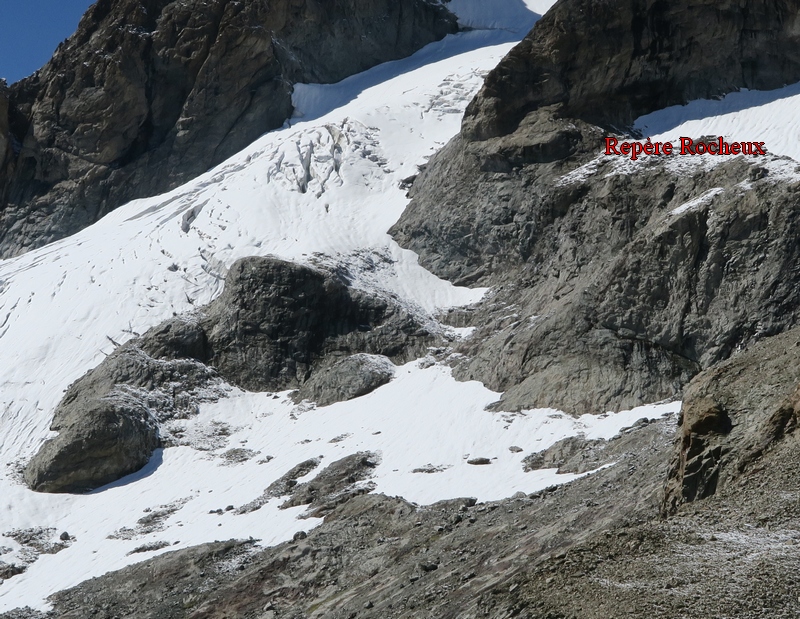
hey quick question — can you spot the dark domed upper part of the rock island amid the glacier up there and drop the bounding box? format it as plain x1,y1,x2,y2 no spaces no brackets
200,258,433,391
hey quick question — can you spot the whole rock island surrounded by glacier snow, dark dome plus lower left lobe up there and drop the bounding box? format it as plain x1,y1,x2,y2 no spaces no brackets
24,258,434,492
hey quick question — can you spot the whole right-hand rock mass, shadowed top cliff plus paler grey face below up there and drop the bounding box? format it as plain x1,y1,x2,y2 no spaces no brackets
391,0,800,413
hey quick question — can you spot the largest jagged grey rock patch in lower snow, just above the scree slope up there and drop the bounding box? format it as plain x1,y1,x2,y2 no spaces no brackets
281,451,380,518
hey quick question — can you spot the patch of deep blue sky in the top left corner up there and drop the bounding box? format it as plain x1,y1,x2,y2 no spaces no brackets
0,0,94,84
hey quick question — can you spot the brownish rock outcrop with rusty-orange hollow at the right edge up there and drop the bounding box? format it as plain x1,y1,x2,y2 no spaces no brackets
663,328,800,513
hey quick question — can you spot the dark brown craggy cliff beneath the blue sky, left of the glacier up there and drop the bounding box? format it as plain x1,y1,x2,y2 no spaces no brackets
0,0,457,257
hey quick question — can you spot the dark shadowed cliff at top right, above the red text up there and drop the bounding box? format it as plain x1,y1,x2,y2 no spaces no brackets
463,0,800,140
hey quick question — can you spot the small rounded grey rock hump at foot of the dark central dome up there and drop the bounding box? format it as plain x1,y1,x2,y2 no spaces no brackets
293,353,395,406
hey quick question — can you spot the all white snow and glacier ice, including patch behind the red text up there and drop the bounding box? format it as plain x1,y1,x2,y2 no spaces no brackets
0,0,800,612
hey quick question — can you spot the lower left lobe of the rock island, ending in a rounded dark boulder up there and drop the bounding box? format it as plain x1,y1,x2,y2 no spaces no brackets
24,345,220,492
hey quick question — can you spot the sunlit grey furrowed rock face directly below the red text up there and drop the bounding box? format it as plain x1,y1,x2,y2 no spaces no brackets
400,149,800,413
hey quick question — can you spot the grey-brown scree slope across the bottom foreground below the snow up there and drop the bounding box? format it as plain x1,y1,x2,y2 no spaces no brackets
10,418,752,619
